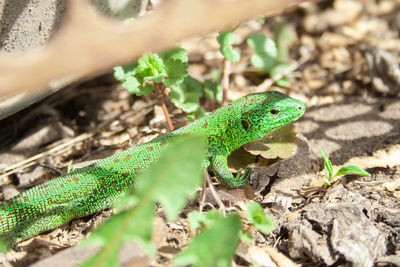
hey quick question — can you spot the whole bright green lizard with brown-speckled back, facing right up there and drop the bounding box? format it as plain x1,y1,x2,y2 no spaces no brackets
0,92,305,246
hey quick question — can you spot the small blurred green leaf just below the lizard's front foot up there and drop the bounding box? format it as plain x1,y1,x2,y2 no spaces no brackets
247,201,275,234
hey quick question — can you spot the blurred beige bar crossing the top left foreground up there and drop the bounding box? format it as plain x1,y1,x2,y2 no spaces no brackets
0,0,310,113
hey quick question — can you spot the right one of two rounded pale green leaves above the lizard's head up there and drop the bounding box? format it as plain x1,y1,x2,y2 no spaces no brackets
247,34,278,72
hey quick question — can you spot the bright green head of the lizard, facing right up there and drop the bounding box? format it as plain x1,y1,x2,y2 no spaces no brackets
240,91,306,141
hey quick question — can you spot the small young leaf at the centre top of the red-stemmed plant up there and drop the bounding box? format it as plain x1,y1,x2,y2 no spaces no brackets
137,54,167,83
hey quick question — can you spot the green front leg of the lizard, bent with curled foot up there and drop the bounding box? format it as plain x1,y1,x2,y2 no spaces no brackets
211,155,253,188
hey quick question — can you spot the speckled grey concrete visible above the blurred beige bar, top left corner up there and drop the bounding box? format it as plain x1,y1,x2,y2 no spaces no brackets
0,0,145,52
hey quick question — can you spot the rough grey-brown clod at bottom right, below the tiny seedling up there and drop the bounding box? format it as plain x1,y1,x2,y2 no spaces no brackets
289,185,386,266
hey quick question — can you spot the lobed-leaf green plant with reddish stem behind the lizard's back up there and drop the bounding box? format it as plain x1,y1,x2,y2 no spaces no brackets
114,48,203,131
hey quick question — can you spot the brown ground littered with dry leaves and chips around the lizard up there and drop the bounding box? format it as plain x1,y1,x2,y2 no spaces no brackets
0,0,400,266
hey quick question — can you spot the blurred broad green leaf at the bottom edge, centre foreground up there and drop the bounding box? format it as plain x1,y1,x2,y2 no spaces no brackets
173,214,241,267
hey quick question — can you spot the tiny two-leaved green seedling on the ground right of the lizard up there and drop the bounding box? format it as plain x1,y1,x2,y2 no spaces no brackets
319,148,371,187
